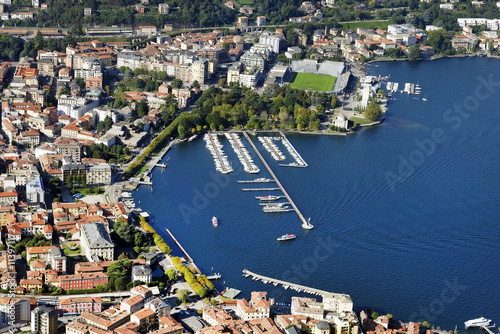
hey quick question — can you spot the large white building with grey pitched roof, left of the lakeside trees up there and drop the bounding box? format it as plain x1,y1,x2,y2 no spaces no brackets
80,223,115,262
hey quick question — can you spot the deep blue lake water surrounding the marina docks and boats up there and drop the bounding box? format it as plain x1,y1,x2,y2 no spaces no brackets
134,58,500,330
